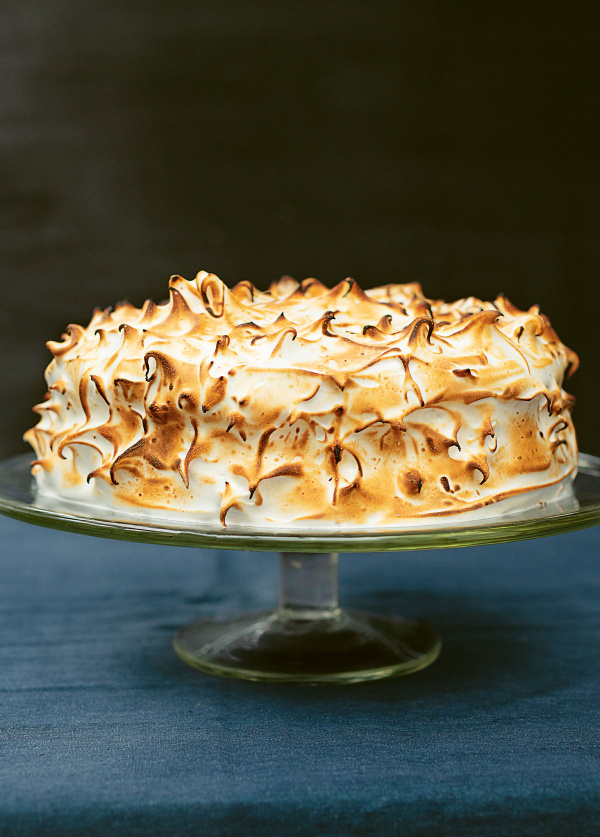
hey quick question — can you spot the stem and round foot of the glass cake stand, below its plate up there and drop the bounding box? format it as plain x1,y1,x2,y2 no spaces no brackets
173,552,441,684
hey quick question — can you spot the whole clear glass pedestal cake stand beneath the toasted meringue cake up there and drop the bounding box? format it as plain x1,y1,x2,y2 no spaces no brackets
0,454,600,683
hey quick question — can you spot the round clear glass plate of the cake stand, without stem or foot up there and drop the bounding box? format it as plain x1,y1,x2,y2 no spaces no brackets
0,453,600,552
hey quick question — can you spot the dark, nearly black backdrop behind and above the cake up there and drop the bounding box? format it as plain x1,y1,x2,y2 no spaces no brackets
0,0,600,456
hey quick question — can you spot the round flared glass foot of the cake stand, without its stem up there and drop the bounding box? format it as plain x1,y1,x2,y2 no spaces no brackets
173,611,440,684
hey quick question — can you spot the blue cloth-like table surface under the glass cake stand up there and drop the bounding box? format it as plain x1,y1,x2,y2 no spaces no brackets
0,519,600,837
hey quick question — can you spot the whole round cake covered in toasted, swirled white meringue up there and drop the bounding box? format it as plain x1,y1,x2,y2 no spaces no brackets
25,272,577,528
